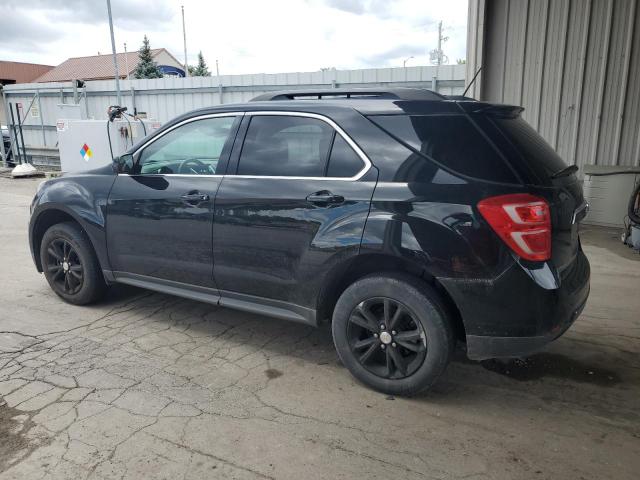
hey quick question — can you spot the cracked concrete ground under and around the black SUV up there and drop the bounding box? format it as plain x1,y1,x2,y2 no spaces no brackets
0,178,640,480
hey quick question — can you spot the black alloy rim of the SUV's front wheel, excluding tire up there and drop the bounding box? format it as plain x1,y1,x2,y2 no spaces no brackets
46,238,84,295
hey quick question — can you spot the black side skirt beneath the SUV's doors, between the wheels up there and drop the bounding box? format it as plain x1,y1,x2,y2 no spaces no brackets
103,270,318,327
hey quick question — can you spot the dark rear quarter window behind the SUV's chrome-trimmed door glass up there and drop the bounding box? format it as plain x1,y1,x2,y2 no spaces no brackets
370,115,517,183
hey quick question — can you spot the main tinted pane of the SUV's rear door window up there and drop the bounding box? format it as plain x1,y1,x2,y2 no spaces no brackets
238,115,333,177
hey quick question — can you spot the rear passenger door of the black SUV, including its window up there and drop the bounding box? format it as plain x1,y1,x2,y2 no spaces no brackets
213,112,377,316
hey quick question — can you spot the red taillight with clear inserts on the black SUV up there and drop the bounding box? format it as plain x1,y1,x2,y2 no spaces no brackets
478,193,551,261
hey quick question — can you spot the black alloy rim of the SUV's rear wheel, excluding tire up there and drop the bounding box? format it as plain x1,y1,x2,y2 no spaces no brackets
347,297,427,379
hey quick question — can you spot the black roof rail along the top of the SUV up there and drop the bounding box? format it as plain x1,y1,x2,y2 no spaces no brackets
251,87,446,102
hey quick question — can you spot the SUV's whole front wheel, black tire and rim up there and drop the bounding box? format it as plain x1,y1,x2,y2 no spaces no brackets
40,222,107,305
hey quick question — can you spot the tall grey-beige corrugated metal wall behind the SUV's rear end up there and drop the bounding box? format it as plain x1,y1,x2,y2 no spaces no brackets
467,0,640,171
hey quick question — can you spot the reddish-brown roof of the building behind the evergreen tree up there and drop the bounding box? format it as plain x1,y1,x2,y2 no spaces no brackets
35,48,180,82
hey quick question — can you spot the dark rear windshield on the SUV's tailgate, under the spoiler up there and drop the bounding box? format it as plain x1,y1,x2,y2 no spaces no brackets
474,115,567,179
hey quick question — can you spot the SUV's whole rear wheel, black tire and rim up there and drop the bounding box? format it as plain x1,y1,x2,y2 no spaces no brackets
332,274,455,395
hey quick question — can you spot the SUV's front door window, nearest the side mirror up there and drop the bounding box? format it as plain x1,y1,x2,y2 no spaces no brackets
138,117,235,175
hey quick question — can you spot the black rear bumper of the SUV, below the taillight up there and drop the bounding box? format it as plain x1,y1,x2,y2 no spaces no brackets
441,249,590,360
